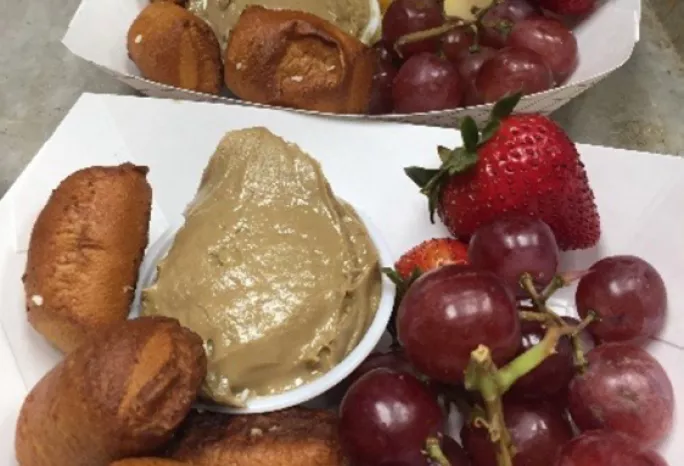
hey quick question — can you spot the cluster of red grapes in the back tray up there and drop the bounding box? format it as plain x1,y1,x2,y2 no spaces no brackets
370,0,578,114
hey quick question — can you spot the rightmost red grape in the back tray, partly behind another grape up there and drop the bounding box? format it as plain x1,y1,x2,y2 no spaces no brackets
506,17,579,84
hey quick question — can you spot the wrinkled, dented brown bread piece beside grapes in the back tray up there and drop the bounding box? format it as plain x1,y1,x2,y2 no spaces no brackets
224,6,375,113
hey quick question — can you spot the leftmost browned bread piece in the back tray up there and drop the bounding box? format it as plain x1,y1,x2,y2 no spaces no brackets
127,1,223,94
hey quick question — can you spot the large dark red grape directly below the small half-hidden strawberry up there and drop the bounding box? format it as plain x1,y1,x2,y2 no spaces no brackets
397,265,521,383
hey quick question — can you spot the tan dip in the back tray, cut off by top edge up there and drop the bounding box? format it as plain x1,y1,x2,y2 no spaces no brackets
188,0,371,46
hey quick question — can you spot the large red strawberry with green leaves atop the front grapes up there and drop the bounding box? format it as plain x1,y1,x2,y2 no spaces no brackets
406,94,600,250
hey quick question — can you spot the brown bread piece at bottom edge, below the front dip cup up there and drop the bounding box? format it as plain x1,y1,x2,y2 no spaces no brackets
169,408,348,466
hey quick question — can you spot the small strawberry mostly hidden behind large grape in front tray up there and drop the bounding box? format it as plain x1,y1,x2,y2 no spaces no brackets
394,238,468,280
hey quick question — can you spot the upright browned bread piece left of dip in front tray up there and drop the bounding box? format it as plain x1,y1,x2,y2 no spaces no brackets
23,163,152,352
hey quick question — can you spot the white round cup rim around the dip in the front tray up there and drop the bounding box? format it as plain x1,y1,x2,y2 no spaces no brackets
130,208,396,414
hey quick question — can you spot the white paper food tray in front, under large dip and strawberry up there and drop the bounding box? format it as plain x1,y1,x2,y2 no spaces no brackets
0,94,684,466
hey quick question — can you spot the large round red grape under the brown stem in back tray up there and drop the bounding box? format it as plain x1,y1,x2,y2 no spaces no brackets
392,53,463,113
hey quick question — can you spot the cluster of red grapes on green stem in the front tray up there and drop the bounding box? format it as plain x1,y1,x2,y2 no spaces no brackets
340,215,674,466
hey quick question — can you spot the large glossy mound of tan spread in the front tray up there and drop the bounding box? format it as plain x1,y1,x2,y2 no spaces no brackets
143,128,381,406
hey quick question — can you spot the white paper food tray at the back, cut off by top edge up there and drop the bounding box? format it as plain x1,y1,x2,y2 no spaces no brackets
62,0,641,128
